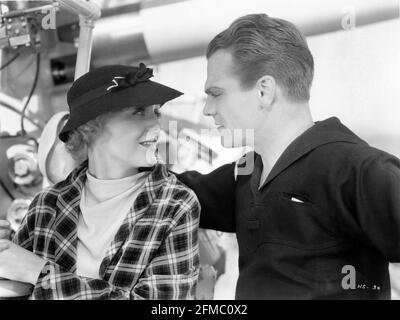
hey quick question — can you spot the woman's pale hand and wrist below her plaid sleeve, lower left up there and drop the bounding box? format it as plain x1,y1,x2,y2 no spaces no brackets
0,240,46,285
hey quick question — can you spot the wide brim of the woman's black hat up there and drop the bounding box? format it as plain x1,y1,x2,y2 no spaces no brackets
59,81,183,142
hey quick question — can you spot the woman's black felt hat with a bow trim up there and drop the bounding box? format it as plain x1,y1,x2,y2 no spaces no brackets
59,63,183,142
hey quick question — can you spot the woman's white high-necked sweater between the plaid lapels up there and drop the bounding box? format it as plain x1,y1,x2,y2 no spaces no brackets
76,171,149,279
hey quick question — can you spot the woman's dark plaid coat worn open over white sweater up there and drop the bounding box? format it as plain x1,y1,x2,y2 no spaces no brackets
13,163,200,299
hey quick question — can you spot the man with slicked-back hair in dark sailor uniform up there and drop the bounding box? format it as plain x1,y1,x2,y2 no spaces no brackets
180,14,400,299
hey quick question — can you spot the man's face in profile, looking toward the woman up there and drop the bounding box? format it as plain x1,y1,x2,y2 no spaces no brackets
203,50,260,148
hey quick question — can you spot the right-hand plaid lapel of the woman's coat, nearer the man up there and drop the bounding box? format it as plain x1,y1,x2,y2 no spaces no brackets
100,164,168,283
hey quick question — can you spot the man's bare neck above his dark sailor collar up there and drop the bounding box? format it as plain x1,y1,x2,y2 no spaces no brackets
255,109,314,187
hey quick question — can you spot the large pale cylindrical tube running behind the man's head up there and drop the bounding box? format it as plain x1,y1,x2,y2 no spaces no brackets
93,0,399,63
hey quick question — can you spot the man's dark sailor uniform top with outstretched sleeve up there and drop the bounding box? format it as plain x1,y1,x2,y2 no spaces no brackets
179,118,400,299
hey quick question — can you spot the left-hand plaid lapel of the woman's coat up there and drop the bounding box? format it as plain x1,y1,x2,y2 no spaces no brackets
54,163,87,272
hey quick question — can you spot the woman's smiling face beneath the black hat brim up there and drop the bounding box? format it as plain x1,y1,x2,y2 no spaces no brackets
91,105,160,168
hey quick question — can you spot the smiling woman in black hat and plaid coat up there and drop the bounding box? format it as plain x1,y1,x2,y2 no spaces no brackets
0,64,200,299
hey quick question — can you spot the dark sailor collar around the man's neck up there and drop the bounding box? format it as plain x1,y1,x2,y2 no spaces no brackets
252,117,366,190
